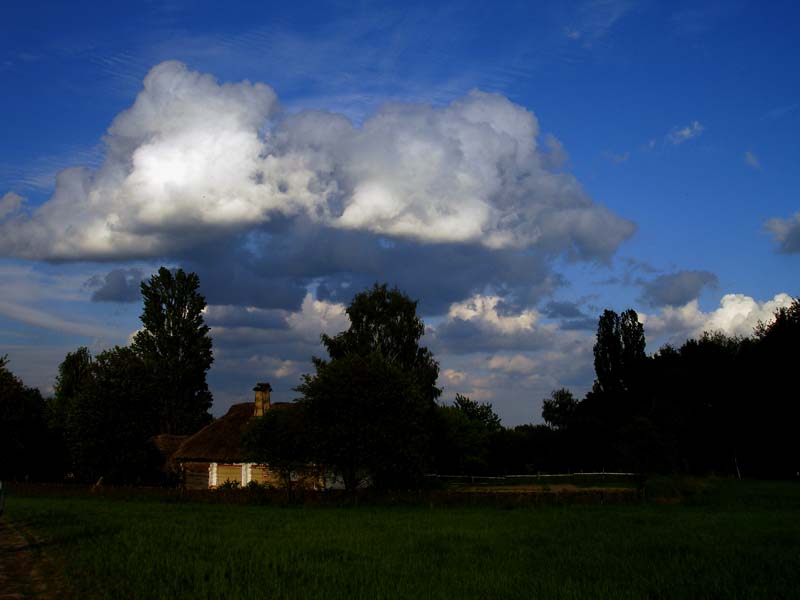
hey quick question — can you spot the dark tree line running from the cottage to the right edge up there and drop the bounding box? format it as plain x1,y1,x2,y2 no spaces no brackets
245,285,800,489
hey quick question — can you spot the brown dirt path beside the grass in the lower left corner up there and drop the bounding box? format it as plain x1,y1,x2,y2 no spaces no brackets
0,516,68,600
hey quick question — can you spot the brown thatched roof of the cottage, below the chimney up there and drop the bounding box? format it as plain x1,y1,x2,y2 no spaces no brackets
172,402,254,463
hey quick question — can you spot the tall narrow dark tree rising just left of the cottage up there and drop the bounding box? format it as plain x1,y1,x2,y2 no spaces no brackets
131,267,214,434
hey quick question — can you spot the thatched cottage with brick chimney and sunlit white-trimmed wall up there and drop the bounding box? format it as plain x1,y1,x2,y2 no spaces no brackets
172,383,280,489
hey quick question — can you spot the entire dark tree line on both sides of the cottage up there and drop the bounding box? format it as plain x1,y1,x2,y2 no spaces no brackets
0,269,800,489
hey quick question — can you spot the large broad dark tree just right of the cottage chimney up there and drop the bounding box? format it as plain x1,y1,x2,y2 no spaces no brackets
297,284,440,489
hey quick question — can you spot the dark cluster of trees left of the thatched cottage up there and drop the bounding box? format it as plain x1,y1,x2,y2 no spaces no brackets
0,267,213,484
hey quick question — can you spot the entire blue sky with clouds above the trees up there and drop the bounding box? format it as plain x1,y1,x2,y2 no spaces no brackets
0,0,800,425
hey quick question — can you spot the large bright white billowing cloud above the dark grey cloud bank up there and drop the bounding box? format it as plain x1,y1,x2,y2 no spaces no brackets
0,61,634,260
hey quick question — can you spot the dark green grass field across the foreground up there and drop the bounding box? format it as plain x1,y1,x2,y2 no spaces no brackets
4,481,800,599
